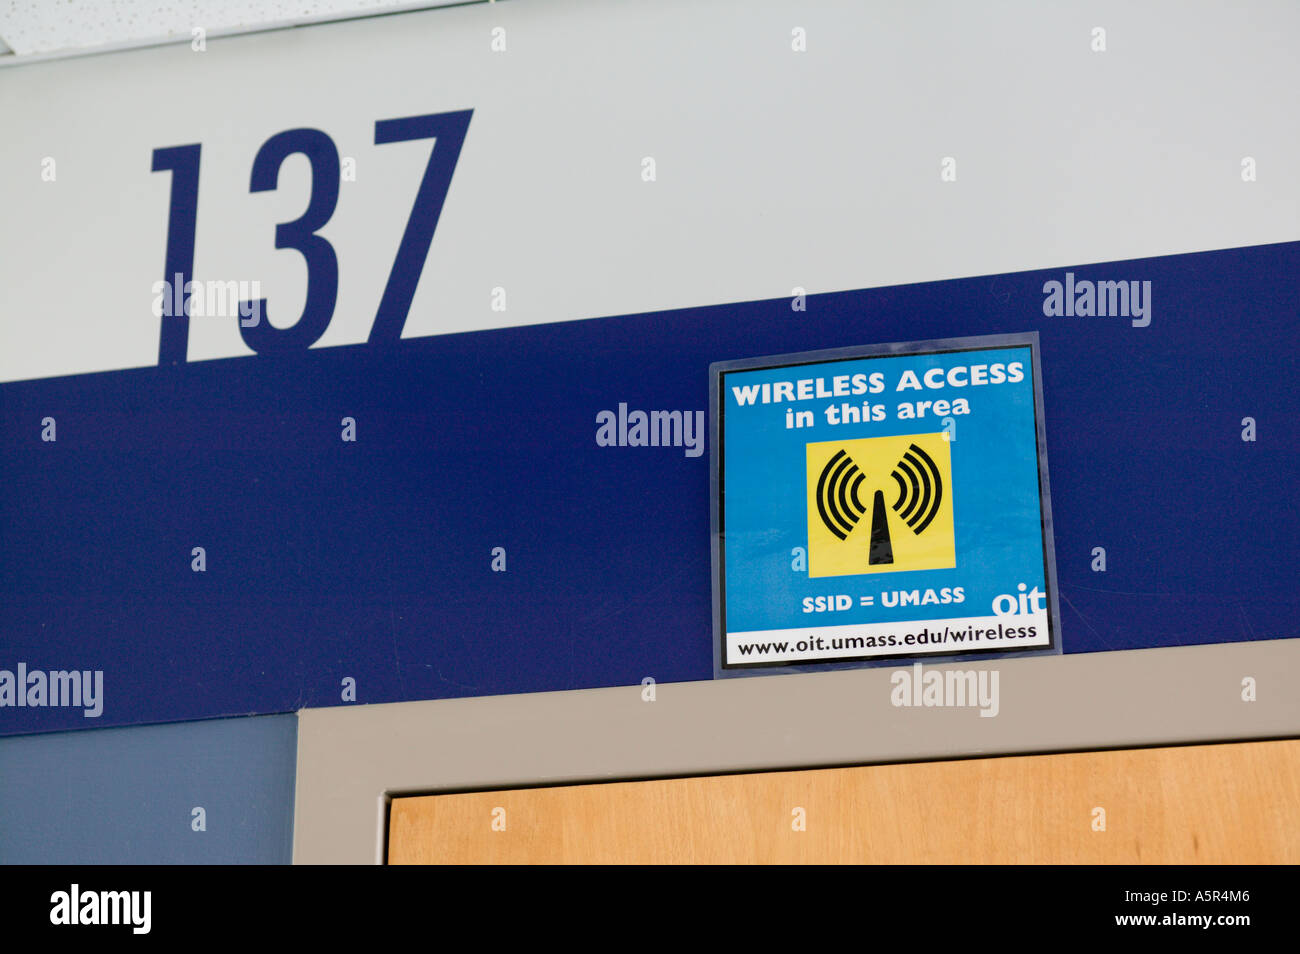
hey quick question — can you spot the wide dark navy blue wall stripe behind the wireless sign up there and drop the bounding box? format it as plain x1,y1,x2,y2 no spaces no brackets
0,242,1300,734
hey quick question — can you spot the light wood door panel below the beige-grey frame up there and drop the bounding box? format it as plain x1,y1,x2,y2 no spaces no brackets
389,741,1300,864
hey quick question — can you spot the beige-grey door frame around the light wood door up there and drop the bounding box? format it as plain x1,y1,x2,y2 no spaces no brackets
294,639,1300,864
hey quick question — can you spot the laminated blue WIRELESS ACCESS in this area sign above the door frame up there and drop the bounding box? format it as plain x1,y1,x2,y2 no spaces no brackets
711,334,1060,675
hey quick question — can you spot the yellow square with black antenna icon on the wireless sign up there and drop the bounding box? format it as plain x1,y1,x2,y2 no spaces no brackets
806,433,957,577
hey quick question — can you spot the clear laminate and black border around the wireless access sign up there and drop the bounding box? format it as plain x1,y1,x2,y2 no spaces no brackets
709,331,1061,678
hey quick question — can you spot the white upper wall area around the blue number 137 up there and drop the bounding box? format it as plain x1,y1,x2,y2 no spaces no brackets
0,0,1300,381
